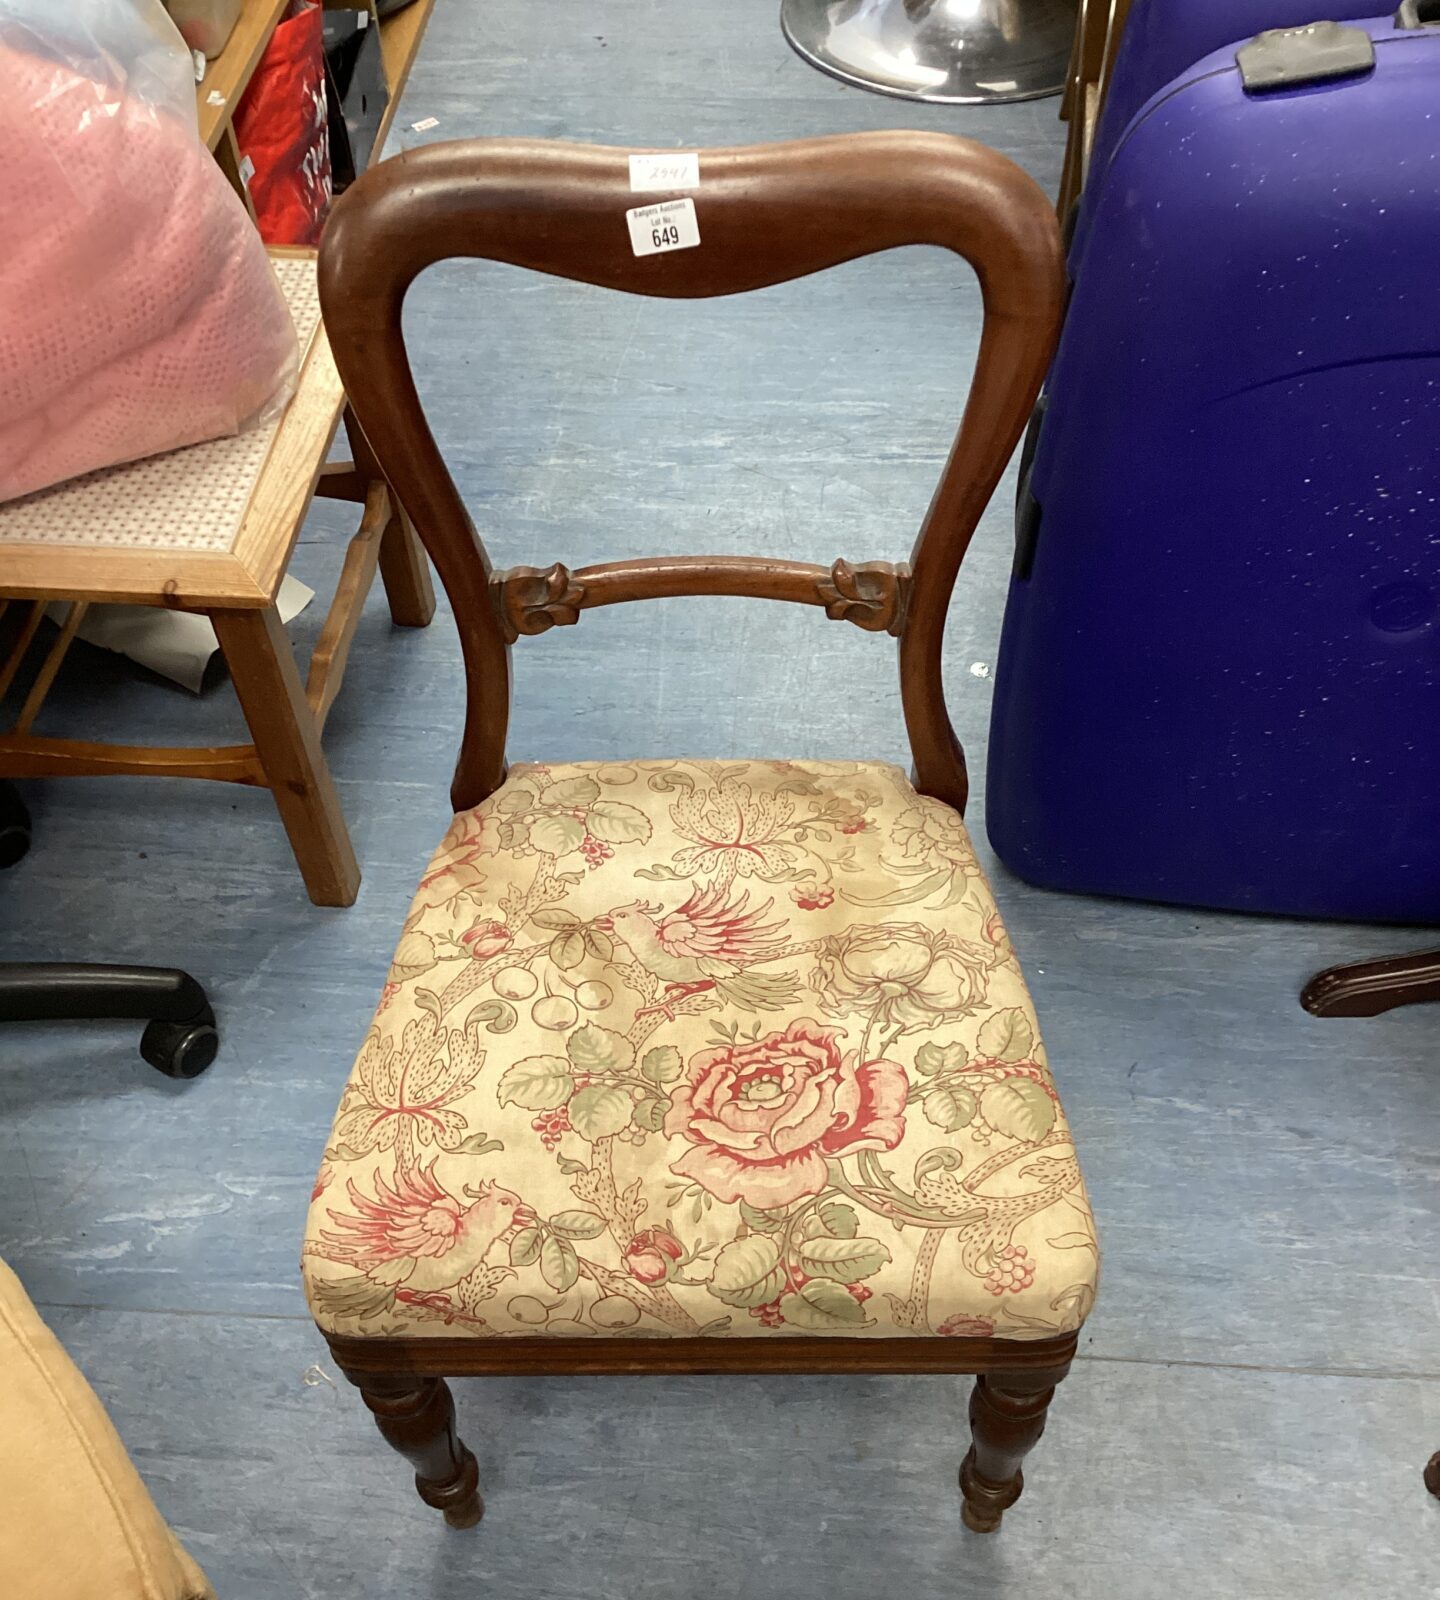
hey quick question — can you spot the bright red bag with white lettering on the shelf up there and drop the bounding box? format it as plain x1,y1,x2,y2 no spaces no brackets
235,0,330,245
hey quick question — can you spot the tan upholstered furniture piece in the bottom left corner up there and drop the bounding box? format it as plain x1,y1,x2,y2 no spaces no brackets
0,1262,214,1600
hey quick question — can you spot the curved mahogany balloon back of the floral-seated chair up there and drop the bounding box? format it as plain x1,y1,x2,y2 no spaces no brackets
320,133,1062,810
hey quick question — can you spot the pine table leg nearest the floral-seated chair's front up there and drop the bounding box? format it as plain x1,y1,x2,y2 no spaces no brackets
211,606,360,906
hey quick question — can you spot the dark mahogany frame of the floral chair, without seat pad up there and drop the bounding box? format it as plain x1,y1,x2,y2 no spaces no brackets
320,133,1077,1531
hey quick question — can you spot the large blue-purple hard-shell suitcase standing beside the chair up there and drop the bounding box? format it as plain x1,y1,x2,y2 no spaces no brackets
987,12,1440,922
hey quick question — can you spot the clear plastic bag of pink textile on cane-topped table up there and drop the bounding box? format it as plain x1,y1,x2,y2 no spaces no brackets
0,0,298,499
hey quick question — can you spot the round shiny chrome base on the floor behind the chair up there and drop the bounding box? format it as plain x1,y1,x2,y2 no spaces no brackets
781,0,1077,104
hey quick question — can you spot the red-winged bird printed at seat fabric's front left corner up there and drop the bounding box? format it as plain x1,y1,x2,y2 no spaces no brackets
304,1157,536,1317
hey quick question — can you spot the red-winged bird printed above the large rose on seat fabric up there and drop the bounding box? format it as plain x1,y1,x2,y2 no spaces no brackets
595,883,798,1022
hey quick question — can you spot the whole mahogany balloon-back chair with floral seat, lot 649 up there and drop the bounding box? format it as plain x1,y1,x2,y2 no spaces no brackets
304,133,1098,1531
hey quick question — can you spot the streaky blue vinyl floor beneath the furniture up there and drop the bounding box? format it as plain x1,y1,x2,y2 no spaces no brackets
0,0,1440,1600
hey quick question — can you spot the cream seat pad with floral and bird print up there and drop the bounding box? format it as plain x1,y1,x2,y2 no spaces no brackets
304,762,1098,1339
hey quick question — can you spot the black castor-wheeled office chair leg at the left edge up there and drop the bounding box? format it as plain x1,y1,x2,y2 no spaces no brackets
0,962,219,1078
